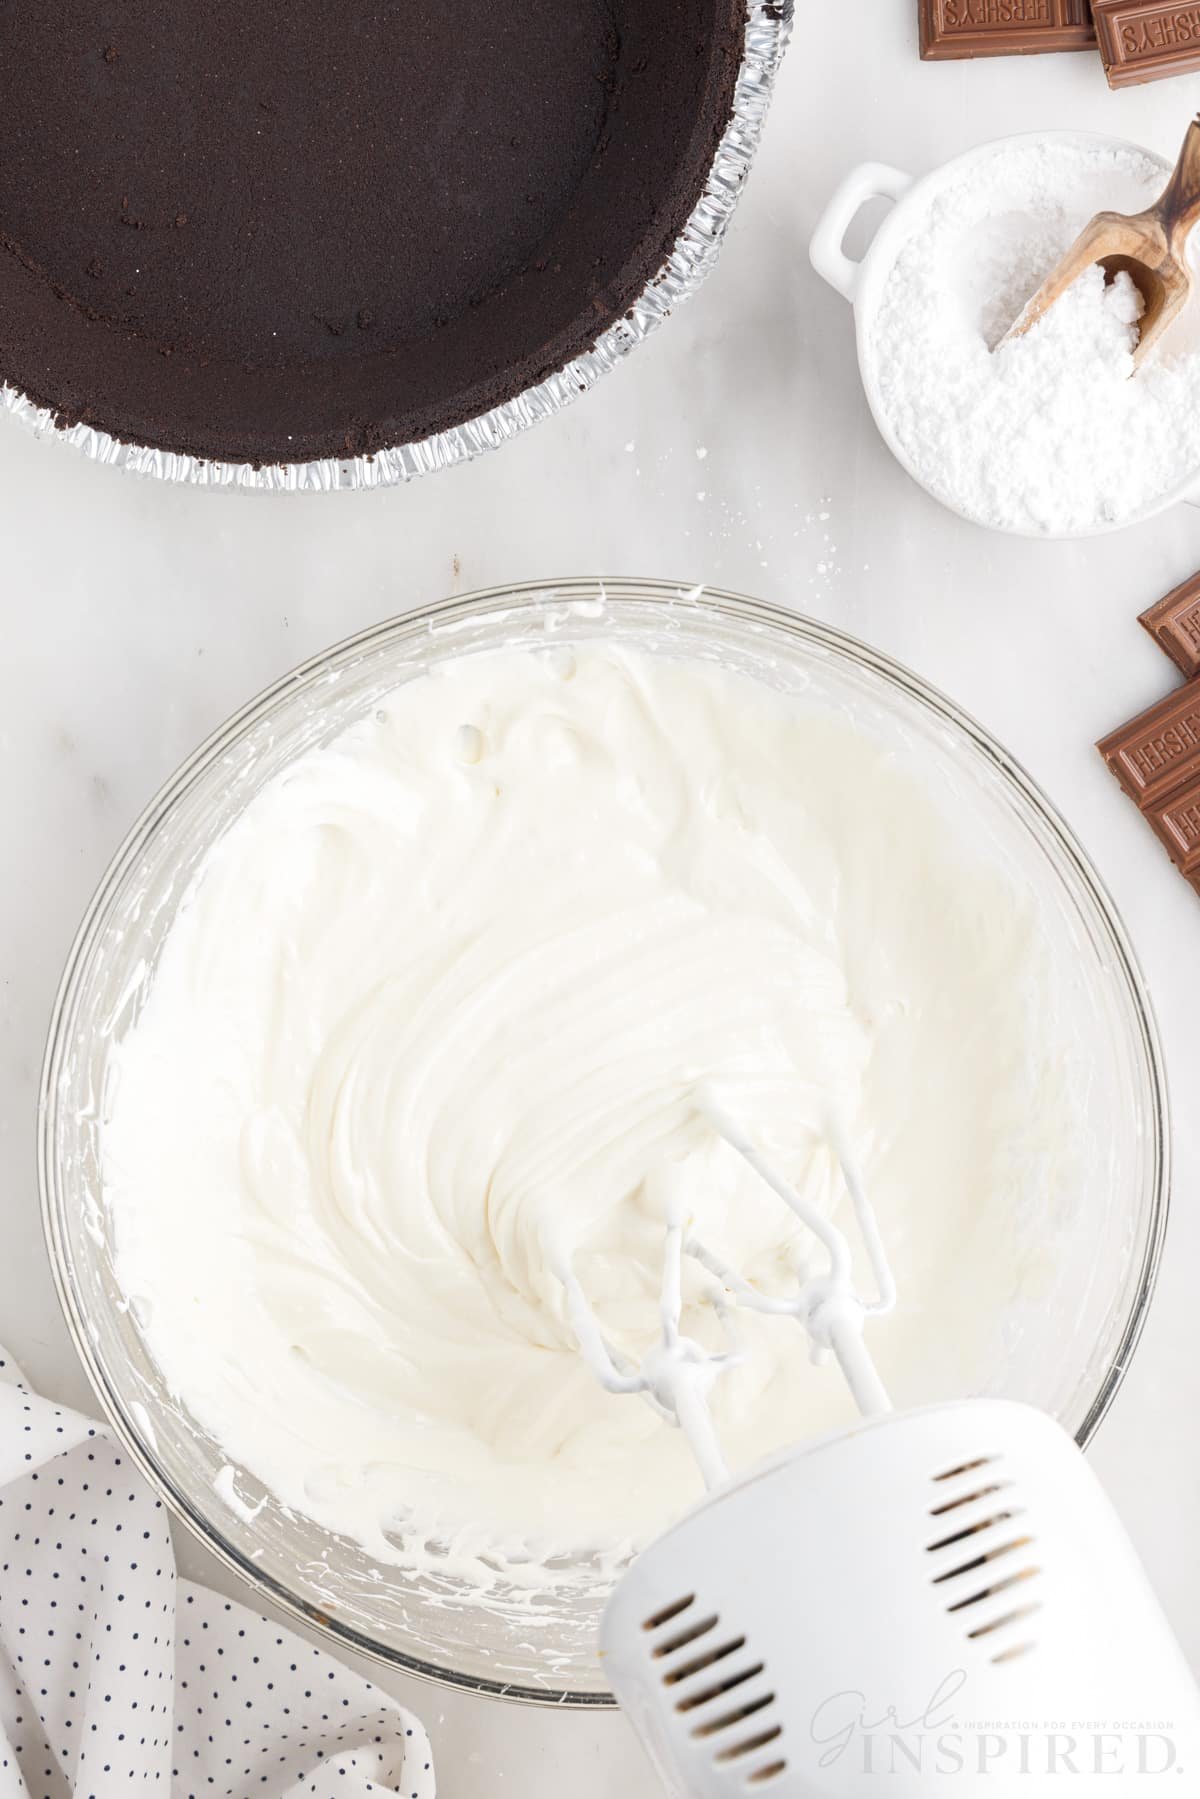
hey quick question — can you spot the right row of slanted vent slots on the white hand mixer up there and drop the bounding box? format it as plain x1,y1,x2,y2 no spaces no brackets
925,1455,1042,1664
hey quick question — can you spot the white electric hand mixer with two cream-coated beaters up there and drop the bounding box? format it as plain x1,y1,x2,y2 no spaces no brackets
560,1092,1200,1799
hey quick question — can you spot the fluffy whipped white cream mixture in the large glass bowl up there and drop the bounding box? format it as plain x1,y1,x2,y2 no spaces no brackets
103,640,1069,1581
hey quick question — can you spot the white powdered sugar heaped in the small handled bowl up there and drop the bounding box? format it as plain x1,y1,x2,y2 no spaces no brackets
864,139,1200,533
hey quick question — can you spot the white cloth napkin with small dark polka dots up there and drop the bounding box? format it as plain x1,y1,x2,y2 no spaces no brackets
0,1349,434,1799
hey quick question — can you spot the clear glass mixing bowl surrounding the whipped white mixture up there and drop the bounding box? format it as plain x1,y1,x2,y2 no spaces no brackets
40,581,1168,1705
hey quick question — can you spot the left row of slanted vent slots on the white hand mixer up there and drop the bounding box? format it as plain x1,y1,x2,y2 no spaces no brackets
642,1592,786,1790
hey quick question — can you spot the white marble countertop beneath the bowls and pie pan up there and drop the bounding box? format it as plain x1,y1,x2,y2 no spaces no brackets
0,0,1200,1799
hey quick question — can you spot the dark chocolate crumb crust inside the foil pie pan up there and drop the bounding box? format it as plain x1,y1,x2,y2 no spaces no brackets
0,0,745,464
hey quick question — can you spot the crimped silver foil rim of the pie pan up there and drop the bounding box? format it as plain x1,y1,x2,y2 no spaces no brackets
0,0,793,493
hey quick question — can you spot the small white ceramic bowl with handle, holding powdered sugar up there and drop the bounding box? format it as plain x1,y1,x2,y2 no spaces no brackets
808,131,1200,538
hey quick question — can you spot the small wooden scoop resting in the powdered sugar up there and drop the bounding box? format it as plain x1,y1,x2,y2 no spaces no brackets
1002,113,1200,367
